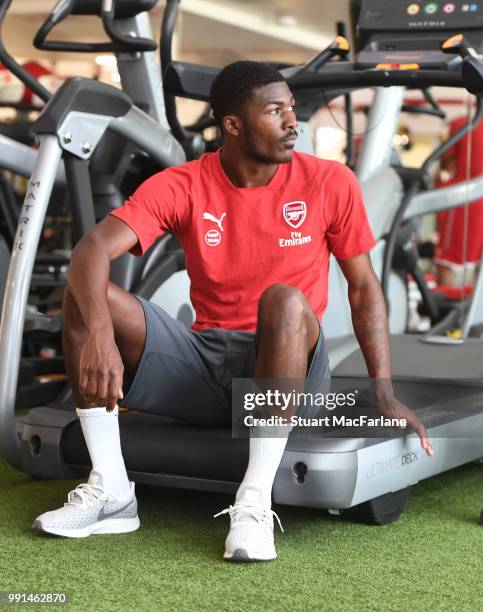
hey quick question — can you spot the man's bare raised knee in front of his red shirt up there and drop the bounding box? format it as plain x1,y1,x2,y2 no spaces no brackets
258,284,308,333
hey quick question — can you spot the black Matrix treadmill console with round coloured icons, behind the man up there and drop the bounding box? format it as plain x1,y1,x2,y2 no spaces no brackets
356,0,483,70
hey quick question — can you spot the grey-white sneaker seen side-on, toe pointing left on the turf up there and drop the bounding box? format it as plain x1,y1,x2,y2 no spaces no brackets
32,482,139,538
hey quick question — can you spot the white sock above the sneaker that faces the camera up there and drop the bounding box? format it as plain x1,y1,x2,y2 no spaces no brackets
236,427,292,508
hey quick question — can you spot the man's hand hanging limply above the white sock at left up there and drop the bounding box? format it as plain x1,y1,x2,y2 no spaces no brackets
79,330,124,411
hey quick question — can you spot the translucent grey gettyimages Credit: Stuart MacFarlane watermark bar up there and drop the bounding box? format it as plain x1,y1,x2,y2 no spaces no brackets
232,376,483,440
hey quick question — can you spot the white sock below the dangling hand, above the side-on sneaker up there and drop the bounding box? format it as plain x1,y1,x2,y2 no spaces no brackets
76,406,131,499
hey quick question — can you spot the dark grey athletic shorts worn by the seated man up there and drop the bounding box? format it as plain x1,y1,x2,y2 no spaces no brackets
120,296,330,425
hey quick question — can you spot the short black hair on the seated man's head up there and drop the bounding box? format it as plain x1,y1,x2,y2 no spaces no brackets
210,61,286,126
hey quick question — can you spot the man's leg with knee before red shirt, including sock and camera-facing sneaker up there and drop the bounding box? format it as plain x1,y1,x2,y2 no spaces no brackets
225,285,320,560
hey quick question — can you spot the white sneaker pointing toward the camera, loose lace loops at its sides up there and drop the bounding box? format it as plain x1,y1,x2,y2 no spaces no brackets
215,490,283,561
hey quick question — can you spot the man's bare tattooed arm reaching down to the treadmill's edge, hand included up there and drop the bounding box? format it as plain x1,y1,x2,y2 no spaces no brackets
338,254,433,455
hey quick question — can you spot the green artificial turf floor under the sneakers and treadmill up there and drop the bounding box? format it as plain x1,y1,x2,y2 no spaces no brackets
0,460,483,612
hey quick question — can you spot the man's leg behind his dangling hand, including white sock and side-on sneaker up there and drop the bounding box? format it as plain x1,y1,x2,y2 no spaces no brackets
34,283,146,537
